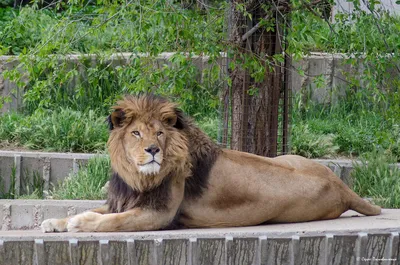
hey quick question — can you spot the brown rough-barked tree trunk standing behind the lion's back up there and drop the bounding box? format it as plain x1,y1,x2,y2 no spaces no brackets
229,0,284,156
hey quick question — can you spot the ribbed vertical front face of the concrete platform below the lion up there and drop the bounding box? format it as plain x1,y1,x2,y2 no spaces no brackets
0,233,399,265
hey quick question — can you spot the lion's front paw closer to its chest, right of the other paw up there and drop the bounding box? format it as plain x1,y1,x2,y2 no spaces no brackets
67,212,102,232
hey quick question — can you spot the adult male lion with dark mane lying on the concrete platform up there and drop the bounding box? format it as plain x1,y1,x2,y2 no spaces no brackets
42,95,381,232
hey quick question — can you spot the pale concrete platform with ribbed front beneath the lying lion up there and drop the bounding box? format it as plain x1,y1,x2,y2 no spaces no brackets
0,209,400,265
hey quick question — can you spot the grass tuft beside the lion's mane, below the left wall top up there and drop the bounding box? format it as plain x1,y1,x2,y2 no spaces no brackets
51,156,111,200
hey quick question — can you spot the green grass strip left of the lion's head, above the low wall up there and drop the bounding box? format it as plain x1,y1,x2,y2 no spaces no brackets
0,109,108,152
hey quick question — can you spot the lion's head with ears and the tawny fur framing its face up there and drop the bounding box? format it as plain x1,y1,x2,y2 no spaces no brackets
108,95,190,191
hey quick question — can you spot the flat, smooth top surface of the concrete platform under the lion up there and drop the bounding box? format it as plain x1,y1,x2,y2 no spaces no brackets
0,209,400,240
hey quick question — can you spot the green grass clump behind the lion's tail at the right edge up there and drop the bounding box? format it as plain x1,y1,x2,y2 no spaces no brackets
351,150,400,208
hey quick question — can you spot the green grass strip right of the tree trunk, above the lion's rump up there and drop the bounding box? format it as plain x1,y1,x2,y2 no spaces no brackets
292,95,400,161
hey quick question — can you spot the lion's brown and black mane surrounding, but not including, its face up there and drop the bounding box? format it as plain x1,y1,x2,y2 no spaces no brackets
107,94,220,212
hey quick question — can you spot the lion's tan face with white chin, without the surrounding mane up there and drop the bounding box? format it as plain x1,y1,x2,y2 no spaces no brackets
123,119,168,175
